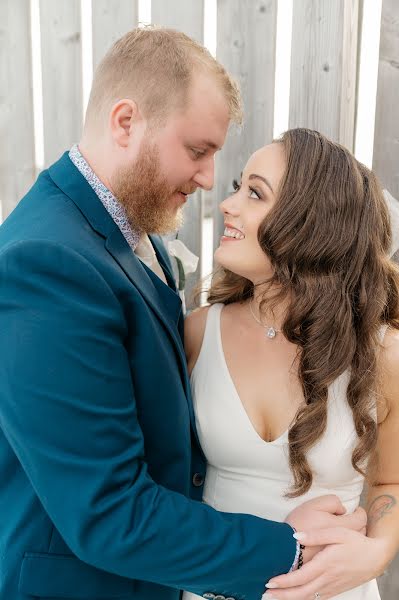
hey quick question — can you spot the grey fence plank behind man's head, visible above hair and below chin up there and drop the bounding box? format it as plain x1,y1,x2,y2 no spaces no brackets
151,0,204,308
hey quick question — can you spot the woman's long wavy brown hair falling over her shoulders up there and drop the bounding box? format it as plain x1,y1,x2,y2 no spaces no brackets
208,128,399,497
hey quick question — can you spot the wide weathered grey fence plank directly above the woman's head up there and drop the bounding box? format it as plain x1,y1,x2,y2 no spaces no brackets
289,0,359,150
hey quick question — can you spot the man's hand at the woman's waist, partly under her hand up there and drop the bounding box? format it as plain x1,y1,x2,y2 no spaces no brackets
285,494,367,564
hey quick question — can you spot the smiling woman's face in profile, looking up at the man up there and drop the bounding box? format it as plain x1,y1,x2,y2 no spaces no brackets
215,143,286,283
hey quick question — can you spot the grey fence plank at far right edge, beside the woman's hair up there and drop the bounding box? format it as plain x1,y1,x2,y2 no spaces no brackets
373,0,399,584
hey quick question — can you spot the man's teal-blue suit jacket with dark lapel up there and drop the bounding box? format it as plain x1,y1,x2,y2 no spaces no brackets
0,153,295,600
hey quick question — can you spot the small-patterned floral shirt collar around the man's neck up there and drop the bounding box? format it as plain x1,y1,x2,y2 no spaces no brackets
69,144,141,251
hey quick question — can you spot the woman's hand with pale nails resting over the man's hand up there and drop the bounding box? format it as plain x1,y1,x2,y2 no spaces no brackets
263,528,386,600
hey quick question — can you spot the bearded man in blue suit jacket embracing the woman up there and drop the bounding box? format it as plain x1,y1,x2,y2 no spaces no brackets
0,29,364,600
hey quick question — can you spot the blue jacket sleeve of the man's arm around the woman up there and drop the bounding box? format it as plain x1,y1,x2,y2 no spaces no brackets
0,241,296,600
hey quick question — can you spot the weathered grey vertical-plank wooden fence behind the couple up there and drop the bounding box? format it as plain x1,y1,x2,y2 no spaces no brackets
0,0,399,600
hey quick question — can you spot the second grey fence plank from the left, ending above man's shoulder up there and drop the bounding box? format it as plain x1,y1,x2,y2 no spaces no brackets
40,0,83,166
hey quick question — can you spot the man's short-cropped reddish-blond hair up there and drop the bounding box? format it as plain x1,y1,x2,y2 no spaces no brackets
86,26,242,127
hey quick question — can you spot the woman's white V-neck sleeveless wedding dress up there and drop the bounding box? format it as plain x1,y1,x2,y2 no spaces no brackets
183,304,380,600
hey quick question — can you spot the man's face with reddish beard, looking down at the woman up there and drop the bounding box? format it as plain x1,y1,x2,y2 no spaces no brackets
112,75,229,234
